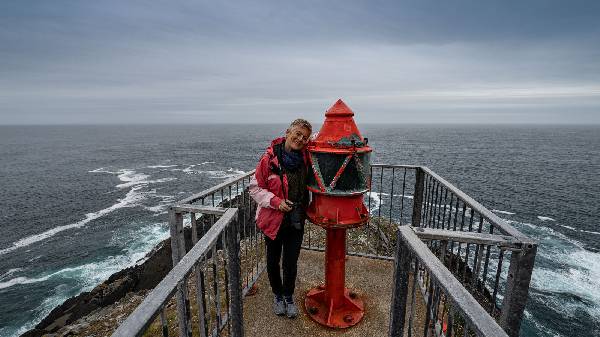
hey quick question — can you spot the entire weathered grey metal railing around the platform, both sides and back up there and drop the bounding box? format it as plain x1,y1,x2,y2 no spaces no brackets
111,164,537,337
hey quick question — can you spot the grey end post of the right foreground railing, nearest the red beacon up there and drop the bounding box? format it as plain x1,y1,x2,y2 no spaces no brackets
389,226,415,337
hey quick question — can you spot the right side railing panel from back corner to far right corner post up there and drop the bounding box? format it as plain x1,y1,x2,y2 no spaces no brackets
412,167,537,336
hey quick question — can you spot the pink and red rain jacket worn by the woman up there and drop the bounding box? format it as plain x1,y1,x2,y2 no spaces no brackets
249,137,307,240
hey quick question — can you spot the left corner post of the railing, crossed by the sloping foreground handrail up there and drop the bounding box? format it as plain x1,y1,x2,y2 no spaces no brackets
169,209,192,336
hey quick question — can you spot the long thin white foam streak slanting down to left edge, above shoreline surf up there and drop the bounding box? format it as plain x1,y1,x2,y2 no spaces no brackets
0,186,145,255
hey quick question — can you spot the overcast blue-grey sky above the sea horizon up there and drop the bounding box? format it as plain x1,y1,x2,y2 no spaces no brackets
0,0,600,124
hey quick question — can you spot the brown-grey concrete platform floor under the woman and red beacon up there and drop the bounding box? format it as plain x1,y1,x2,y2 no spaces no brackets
239,250,393,337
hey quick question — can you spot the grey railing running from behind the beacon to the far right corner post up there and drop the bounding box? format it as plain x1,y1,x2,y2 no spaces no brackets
303,164,537,336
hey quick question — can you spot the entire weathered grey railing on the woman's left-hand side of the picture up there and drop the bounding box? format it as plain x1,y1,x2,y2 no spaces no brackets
114,171,266,337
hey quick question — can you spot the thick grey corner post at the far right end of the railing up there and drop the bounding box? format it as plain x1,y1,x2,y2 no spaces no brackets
500,242,537,337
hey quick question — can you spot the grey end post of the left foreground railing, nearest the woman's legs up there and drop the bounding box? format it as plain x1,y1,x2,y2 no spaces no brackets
226,215,244,337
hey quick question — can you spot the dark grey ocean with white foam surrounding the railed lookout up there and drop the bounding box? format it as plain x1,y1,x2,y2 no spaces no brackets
0,125,600,337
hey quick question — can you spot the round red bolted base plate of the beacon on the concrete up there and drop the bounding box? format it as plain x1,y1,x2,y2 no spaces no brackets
304,286,365,328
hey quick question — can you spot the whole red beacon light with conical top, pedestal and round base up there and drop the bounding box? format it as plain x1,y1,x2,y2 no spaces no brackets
304,99,373,328
